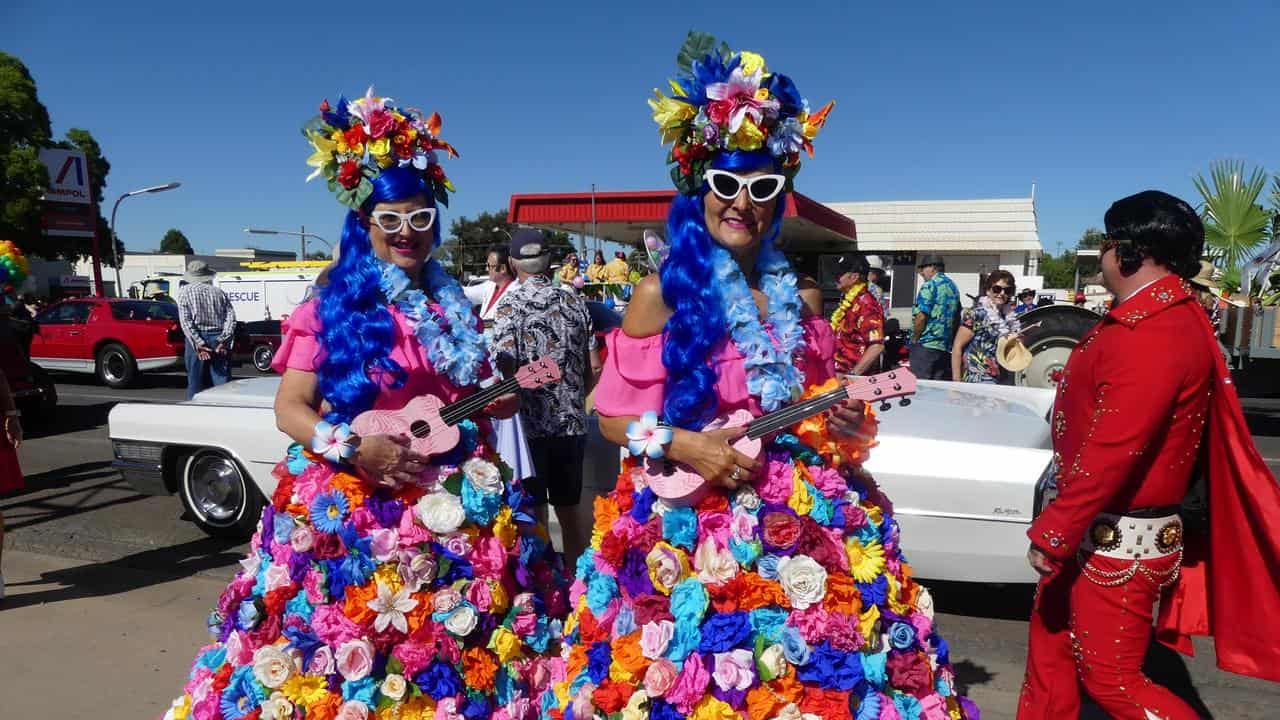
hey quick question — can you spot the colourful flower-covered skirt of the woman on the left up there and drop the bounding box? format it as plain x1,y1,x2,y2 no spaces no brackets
165,430,568,720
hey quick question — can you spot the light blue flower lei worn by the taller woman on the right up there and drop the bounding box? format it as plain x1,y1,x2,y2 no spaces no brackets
712,245,804,413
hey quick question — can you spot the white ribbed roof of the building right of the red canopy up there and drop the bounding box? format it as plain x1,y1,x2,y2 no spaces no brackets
827,197,1044,252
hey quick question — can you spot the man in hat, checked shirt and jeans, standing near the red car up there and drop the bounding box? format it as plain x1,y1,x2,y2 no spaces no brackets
178,260,236,400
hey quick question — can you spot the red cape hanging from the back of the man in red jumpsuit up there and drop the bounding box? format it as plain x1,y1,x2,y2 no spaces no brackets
1156,308,1280,682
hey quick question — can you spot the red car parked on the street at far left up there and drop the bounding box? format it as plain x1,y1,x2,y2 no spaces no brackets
31,297,184,388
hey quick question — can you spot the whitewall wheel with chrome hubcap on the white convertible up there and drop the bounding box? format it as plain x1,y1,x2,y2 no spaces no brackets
178,447,266,539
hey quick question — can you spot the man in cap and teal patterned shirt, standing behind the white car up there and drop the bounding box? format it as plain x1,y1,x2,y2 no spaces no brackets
911,255,960,380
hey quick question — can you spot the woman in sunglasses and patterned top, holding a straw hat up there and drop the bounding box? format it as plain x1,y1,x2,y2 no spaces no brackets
951,270,1021,383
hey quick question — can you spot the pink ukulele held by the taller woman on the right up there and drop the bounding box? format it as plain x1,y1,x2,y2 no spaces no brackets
644,369,915,505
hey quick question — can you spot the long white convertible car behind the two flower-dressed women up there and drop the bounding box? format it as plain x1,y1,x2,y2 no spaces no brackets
109,377,1052,583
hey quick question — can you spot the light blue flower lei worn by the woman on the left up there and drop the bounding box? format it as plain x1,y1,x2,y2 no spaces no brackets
375,259,488,387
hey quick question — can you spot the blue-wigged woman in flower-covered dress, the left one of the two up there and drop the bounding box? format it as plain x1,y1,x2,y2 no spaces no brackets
166,90,568,720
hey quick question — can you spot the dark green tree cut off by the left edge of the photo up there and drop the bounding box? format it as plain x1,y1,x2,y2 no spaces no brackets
0,53,52,252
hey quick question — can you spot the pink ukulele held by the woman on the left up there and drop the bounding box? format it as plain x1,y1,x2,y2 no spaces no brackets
351,357,561,457
